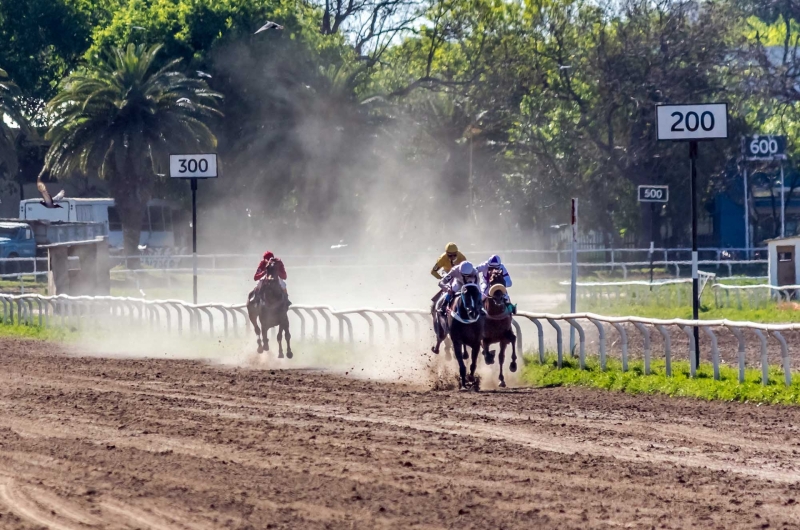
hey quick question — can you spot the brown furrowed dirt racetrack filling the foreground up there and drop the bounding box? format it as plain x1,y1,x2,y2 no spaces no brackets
0,339,800,530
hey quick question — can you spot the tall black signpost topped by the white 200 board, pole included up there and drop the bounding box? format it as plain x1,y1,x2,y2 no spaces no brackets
656,103,728,366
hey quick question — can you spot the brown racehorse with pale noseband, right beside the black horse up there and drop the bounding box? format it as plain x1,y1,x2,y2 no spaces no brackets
482,269,517,387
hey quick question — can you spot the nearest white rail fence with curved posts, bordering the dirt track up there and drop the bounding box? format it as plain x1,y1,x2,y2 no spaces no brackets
0,294,800,385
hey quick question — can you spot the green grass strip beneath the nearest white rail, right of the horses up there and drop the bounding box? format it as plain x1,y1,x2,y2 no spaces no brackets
522,355,800,404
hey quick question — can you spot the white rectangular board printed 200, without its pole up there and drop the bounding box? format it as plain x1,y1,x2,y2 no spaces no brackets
656,103,728,140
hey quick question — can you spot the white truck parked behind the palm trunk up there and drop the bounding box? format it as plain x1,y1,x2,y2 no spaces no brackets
19,198,179,249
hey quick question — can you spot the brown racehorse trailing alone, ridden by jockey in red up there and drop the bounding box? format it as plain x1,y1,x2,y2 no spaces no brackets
247,263,293,359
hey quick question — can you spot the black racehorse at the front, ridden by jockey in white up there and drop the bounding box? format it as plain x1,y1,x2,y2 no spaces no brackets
447,283,485,390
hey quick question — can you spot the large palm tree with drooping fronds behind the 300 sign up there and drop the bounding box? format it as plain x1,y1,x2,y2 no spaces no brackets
43,44,222,256
